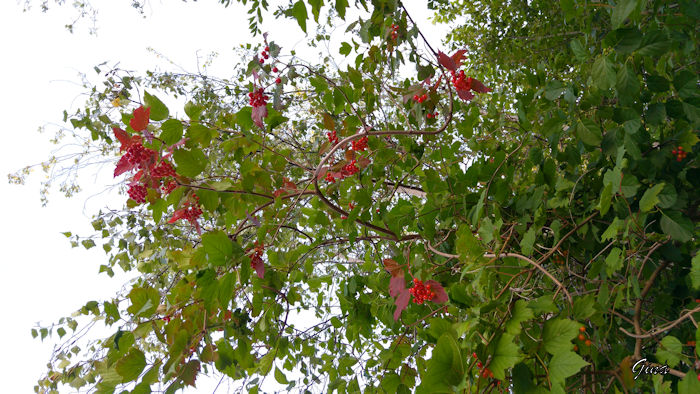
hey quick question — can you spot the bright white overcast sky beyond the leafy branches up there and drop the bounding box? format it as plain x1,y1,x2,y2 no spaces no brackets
0,0,446,393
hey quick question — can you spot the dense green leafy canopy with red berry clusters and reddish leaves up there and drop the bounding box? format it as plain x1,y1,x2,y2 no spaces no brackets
17,0,700,393
